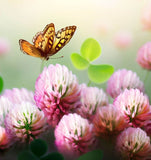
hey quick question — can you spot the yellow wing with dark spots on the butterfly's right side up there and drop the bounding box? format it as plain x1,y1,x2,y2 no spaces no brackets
49,26,76,56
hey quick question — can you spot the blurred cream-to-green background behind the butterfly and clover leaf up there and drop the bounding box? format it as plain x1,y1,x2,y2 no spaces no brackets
0,0,151,98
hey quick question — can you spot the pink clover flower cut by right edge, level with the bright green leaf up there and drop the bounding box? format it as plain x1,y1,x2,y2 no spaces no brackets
136,42,151,70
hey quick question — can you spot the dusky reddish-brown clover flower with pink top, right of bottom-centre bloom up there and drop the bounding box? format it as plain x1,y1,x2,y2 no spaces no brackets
93,104,129,138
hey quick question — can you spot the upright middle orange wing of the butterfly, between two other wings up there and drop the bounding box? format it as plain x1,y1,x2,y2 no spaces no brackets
33,23,55,54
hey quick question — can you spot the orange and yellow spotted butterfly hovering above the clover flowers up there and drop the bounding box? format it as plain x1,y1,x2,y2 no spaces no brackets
19,23,76,60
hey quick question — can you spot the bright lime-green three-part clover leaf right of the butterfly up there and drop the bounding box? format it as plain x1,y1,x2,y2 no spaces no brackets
71,38,114,83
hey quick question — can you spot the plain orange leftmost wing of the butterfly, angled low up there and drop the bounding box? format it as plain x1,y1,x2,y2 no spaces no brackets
19,39,43,58
